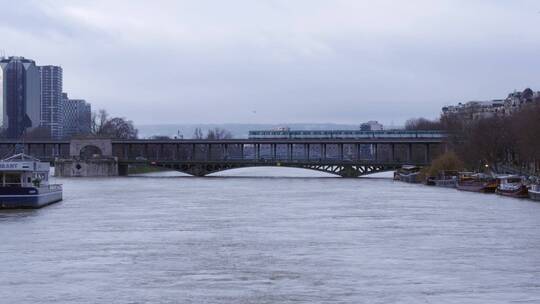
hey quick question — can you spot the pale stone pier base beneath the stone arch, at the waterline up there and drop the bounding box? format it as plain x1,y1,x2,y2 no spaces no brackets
54,157,118,177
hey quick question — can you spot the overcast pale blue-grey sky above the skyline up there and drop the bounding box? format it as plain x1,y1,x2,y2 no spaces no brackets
0,0,540,124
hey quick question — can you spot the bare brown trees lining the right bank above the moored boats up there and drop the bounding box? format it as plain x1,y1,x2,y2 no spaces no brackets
406,103,540,170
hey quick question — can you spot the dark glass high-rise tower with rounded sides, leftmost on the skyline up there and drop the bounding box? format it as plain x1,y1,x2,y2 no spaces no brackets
0,57,41,138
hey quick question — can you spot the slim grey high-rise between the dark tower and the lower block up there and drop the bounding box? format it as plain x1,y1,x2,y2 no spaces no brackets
38,65,62,138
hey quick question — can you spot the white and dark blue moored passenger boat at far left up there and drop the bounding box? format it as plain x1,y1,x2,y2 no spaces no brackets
0,153,62,209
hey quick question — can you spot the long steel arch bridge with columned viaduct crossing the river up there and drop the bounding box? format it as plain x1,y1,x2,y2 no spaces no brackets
0,136,446,177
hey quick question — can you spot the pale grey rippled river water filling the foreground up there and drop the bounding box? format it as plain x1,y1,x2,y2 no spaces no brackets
0,169,540,303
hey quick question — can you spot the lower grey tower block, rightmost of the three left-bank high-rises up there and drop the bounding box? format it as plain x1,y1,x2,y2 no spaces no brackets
62,93,92,138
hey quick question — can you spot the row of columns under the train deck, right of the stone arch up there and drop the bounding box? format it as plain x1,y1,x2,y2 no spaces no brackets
113,140,441,162
